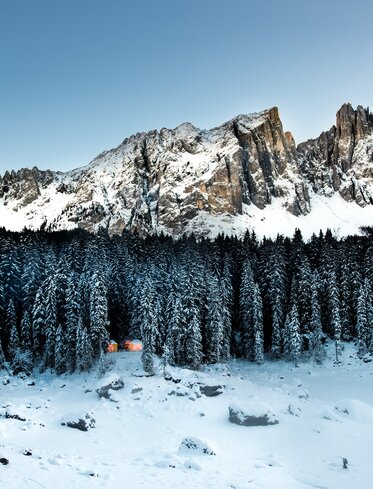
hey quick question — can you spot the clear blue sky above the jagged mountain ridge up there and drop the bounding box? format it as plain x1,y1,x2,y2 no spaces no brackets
0,0,373,173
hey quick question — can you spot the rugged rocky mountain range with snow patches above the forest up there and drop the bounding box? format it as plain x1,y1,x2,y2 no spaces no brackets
0,104,373,236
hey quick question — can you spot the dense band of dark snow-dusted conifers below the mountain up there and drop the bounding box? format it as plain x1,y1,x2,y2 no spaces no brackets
0,225,373,374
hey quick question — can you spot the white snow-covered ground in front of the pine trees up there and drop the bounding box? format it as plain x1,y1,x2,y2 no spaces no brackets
0,346,373,489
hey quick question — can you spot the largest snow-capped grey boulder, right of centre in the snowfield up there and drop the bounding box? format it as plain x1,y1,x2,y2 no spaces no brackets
229,402,279,426
